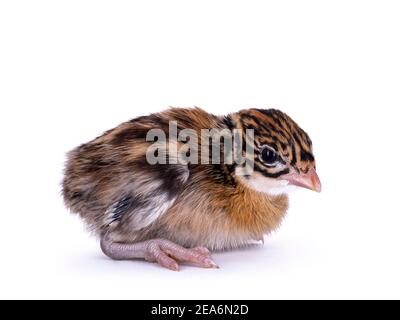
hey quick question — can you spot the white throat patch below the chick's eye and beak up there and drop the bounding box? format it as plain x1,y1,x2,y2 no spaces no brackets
240,172,296,195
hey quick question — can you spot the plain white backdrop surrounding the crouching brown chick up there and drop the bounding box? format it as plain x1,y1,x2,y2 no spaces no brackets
0,0,400,299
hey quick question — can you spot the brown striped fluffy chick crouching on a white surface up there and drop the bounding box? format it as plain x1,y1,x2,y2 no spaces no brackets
62,107,321,271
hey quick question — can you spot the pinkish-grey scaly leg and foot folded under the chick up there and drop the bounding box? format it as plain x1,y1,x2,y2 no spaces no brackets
100,235,218,271
